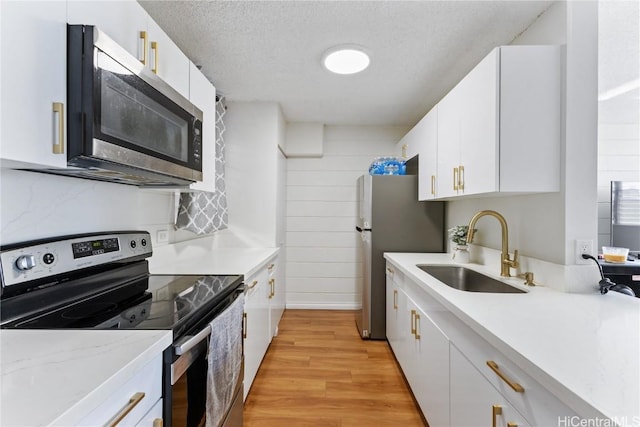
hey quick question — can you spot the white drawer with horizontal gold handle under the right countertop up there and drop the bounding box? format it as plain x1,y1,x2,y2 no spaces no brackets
454,330,576,426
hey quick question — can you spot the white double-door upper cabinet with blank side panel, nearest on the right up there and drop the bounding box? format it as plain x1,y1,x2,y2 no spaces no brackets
436,46,561,198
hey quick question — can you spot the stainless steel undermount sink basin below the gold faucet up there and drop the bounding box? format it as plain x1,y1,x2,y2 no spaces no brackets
417,264,526,294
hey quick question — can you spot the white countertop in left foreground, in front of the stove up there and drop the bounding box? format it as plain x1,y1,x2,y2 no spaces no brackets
0,329,172,427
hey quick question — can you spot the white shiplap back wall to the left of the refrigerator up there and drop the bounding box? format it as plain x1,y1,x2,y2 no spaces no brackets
286,126,408,309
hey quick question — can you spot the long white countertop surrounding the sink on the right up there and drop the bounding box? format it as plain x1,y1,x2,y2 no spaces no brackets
385,253,640,426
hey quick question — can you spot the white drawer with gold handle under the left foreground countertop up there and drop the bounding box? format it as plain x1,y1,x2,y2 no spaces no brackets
79,354,162,426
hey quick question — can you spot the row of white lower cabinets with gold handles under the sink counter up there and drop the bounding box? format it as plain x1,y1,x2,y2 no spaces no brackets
386,262,577,427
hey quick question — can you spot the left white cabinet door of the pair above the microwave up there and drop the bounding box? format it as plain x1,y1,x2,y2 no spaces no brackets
67,0,148,61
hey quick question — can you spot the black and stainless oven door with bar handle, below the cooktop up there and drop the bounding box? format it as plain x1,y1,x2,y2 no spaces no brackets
163,286,244,427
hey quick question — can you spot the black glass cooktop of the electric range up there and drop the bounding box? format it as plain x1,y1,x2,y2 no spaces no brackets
2,275,242,337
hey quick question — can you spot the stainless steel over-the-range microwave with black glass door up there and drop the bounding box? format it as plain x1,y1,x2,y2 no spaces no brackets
58,25,202,187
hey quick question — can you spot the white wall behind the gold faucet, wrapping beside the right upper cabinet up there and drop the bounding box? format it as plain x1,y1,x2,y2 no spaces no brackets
447,2,597,265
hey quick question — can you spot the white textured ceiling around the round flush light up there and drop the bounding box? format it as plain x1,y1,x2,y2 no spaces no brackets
140,0,551,125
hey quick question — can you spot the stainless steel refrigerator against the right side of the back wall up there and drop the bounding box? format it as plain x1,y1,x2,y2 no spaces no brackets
356,175,445,339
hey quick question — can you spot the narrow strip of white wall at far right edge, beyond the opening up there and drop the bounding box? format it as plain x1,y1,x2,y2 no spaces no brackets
598,1,640,247
